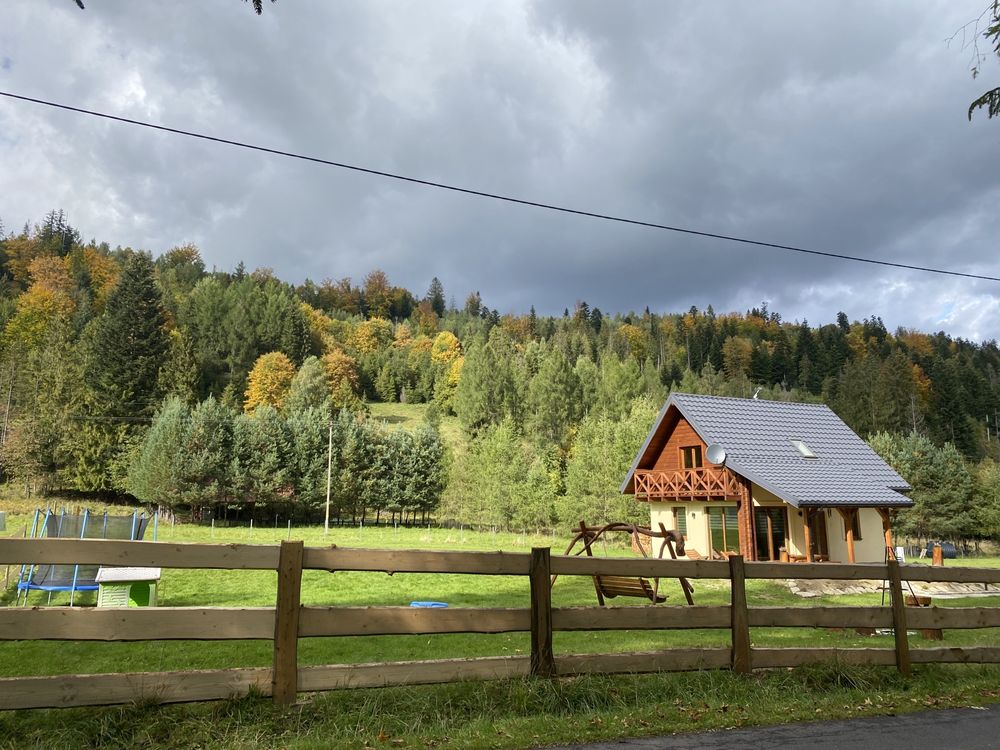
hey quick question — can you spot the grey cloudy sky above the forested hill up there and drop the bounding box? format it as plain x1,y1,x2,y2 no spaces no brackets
0,0,1000,340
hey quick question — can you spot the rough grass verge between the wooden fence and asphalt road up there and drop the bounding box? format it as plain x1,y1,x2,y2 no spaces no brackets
0,664,1000,750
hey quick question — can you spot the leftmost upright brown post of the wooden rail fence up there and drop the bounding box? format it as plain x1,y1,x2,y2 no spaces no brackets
271,541,302,706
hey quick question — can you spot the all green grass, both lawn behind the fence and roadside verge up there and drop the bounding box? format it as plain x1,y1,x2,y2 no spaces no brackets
0,507,1000,749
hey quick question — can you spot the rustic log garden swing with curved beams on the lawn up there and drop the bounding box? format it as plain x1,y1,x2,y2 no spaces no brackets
552,521,694,607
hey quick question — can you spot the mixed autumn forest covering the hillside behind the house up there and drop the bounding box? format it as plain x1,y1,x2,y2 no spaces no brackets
0,211,1000,542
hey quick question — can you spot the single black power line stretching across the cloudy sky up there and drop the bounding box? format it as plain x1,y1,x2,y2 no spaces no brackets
0,91,1000,281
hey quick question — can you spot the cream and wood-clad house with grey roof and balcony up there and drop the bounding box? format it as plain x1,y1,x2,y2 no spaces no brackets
621,393,913,562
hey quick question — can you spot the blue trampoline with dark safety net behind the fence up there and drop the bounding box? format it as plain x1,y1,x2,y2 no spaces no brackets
15,509,156,607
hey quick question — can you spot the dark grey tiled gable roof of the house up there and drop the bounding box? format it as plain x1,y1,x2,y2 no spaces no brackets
622,393,913,507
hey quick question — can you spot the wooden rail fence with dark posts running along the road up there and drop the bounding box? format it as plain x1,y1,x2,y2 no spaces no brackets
0,539,1000,709
